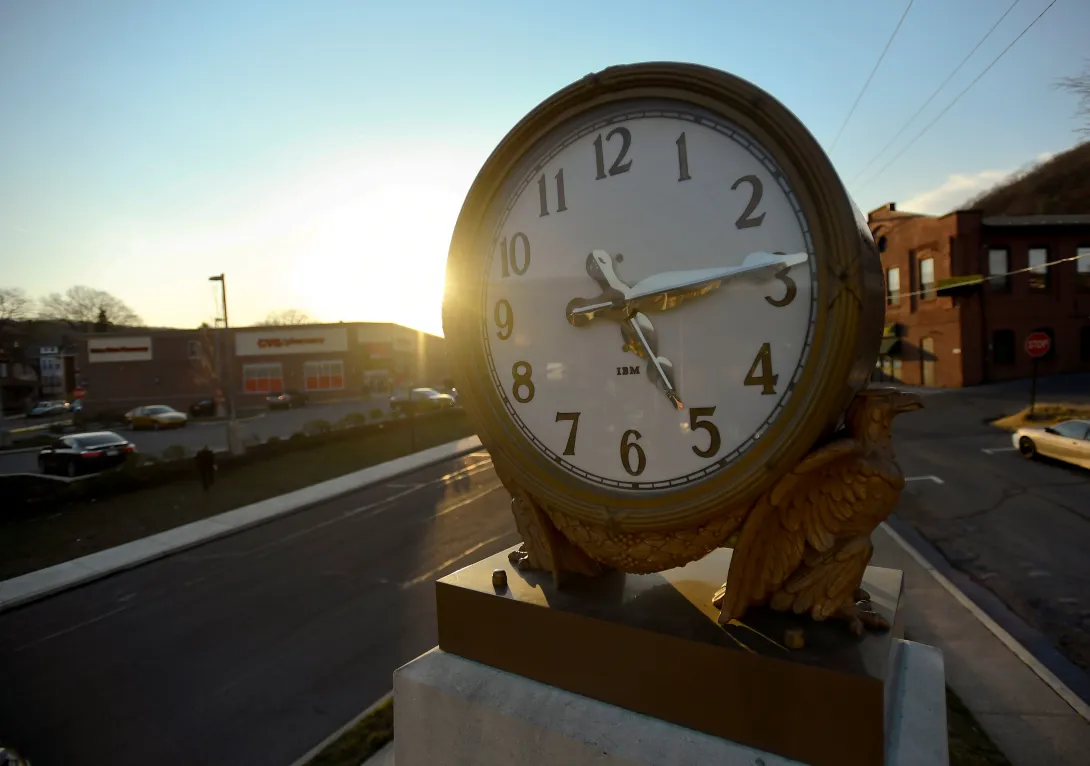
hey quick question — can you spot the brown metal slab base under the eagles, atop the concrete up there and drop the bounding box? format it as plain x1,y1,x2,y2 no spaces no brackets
436,546,904,766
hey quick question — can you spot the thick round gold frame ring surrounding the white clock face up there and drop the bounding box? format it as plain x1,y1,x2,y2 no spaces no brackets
443,62,884,536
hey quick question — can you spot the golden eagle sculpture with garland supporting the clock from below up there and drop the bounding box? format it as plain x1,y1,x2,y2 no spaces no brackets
496,388,923,634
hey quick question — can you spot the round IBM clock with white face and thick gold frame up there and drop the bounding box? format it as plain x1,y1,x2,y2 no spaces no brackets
444,63,884,572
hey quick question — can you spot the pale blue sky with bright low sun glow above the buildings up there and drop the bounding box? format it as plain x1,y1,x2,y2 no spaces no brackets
0,0,1090,333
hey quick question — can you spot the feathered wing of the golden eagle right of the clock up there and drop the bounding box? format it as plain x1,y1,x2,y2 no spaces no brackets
719,438,867,622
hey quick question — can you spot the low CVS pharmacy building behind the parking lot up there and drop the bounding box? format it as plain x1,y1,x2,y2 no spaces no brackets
76,323,450,411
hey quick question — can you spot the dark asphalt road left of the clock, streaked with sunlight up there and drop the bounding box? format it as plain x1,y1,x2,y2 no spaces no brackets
0,453,518,766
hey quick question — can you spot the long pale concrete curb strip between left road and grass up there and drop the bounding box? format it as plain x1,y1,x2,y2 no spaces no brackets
0,436,482,612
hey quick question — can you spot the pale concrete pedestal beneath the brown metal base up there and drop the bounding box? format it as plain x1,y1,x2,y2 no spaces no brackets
393,640,948,766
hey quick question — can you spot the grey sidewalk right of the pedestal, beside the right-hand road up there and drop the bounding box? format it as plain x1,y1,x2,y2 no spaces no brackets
871,524,1090,766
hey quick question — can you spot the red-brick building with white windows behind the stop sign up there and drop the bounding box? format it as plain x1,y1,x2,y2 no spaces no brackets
868,204,1090,388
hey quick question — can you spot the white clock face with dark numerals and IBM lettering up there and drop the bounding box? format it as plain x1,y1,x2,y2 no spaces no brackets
481,102,818,491
